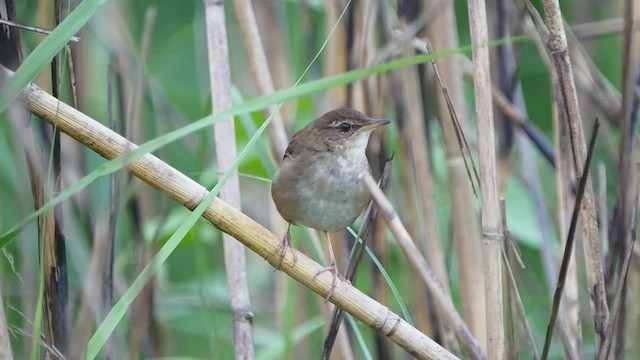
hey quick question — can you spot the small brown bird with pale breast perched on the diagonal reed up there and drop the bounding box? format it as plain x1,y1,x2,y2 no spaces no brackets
271,108,389,299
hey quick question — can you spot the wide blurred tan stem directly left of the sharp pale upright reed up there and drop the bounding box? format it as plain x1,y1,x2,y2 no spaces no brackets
426,0,487,350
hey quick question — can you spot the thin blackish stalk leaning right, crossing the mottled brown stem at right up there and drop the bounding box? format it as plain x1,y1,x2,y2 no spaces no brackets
541,120,600,360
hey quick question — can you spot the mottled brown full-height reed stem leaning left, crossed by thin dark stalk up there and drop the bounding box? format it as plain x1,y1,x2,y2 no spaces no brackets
543,0,609,349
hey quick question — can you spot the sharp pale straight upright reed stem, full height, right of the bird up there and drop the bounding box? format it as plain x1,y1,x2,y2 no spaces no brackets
468,0,505,359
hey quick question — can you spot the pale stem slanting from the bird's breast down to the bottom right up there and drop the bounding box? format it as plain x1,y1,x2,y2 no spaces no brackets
361,173,486,359
